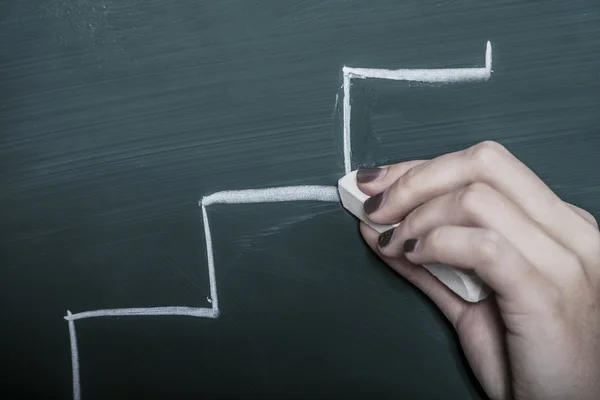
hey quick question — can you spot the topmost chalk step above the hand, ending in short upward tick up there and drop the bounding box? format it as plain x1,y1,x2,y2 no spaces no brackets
342,41,492,174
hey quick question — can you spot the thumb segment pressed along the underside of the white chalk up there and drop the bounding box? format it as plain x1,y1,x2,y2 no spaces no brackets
360,222,467,322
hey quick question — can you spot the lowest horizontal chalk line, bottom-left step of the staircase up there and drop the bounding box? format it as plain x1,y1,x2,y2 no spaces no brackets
64,306,219,321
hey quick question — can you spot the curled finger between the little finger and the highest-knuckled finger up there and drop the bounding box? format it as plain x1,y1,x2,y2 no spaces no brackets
379,183,574,276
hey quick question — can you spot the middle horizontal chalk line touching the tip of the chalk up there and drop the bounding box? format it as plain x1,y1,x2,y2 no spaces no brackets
200,185,340,207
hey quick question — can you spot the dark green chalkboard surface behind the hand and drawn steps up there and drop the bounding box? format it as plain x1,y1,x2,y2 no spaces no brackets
0,0,600,400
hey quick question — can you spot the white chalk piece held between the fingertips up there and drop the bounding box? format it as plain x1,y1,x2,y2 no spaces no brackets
338,171,489,303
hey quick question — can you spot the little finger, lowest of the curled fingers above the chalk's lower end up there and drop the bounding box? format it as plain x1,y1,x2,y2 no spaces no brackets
405,226,549,307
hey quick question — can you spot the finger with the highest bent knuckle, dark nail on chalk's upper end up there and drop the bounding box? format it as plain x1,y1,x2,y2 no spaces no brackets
364,142,600,263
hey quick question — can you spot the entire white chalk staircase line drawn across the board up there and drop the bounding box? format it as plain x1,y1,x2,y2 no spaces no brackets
64,42,492,400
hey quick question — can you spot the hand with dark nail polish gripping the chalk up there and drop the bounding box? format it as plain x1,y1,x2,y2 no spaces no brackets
357,142,600,400
